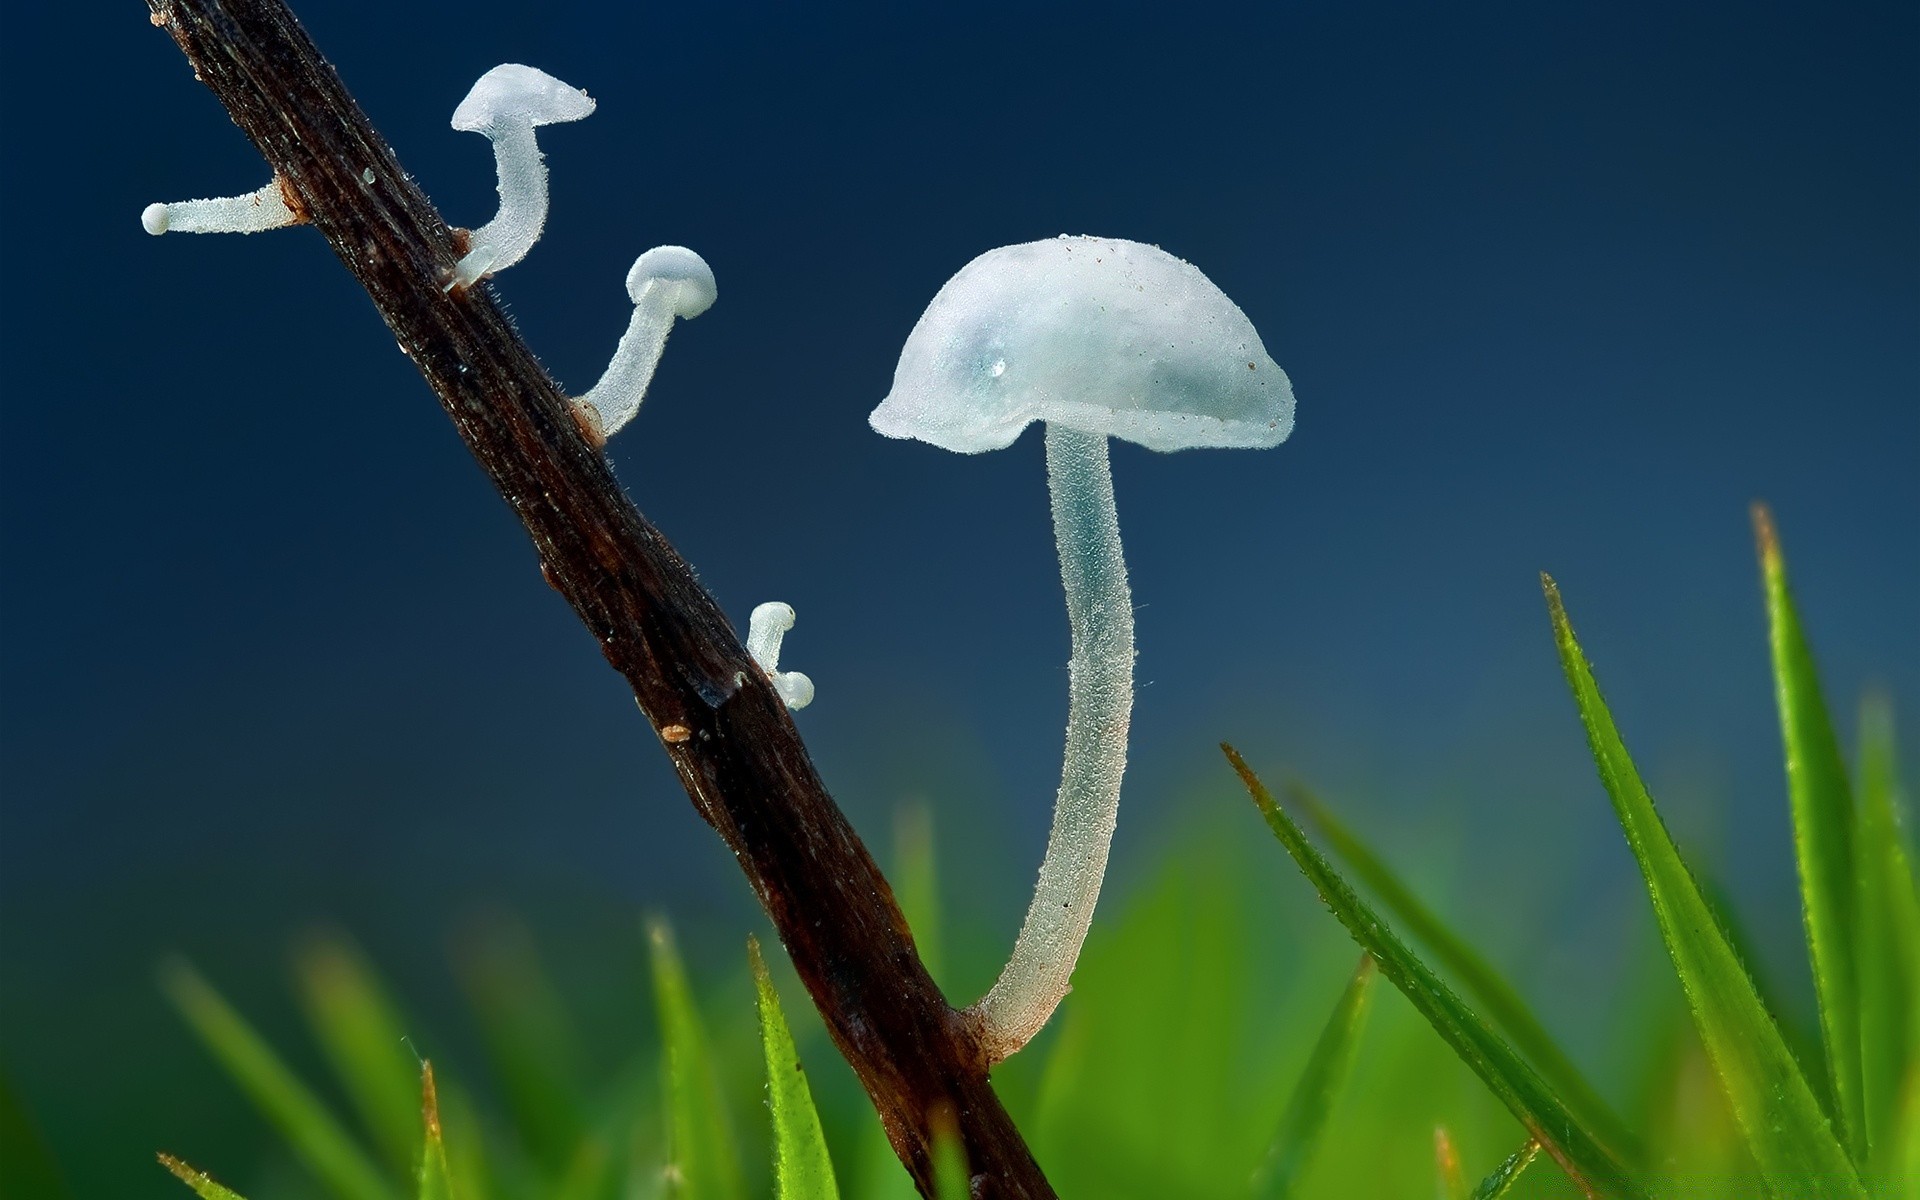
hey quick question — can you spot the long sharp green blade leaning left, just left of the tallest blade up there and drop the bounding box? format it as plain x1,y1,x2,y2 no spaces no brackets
1542,576,1866,1200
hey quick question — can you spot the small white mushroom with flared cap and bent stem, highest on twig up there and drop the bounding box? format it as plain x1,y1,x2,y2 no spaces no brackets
449,63,593,290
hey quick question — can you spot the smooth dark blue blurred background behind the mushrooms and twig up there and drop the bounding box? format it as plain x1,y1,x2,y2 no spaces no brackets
0,0,1920,1188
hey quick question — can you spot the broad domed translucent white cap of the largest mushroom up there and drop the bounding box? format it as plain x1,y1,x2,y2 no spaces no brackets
868,234,1294,453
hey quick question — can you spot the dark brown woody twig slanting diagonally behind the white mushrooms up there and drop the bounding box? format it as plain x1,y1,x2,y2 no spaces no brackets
150,0,1054,1200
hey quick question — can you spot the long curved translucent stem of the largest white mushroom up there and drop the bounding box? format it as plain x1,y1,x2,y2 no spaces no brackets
966,422,1133,1064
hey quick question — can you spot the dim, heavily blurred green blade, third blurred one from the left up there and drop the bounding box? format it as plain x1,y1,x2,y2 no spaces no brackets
459,920,588,1179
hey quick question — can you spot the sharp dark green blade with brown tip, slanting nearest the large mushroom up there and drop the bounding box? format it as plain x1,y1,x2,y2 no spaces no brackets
1221,745,1647,1198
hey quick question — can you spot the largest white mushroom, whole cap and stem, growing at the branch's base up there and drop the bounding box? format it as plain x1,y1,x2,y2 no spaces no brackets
868,236,1294,1062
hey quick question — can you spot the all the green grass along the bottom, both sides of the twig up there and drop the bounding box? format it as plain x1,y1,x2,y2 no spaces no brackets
63,511,1920,1200
